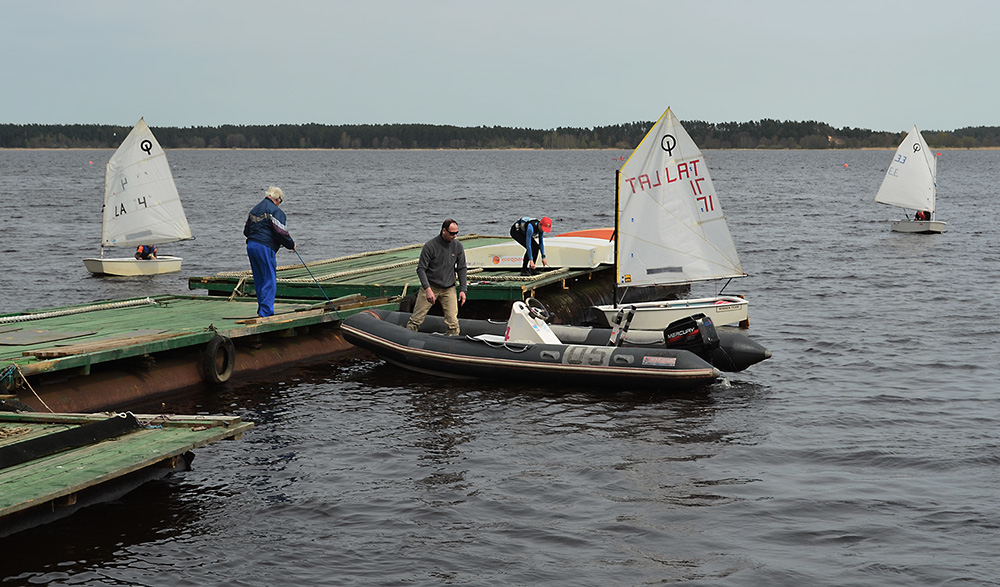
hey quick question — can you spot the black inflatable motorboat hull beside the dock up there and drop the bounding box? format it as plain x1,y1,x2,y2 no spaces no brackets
341,309,771,390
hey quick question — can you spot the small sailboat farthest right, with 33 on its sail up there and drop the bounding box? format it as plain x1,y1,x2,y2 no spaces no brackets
875,125,946,234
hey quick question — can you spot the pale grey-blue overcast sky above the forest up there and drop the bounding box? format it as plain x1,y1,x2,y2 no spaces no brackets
0,0,1000,132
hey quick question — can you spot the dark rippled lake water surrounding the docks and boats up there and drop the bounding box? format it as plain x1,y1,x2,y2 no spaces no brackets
0,151,1000,586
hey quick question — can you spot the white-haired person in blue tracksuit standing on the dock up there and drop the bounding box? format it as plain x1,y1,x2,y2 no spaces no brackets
243,186,299,318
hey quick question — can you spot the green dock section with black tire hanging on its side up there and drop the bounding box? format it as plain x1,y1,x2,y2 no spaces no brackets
0,295,398,412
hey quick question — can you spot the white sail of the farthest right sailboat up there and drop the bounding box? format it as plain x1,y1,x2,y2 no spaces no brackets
875,125,937,212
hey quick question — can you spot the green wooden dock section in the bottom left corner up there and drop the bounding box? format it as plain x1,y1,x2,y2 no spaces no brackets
0,412,253,536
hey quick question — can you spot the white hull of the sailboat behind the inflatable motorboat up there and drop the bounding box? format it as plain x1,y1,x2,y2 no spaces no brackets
595,296,750,330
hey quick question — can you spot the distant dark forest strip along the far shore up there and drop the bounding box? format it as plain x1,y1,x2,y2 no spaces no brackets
0,119,1000,150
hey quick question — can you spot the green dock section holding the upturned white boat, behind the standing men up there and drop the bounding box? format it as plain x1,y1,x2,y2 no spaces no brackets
188,234,614,322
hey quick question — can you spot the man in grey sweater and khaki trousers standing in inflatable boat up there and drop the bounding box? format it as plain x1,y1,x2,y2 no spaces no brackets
406,218,469,336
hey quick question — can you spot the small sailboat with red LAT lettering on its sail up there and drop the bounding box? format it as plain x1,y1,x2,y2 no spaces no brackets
595,108,749,330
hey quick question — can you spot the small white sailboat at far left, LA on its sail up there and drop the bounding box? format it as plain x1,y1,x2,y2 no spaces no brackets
83,118,193,276
